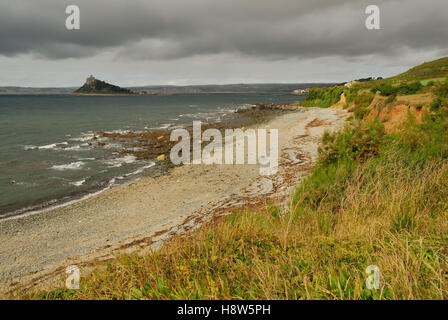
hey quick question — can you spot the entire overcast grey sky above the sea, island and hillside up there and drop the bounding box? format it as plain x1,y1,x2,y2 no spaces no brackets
0,0,448,87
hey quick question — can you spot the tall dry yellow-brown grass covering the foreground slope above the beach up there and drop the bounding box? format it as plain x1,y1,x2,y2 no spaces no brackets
24,156,448,299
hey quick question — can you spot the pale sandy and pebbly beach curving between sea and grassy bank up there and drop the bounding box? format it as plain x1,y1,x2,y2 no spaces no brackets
0,108,347,294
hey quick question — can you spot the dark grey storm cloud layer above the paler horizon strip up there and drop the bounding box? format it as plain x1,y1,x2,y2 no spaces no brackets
0,0,448,60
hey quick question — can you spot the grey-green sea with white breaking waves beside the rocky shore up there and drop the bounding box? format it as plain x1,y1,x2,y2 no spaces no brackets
0,94,303,219
